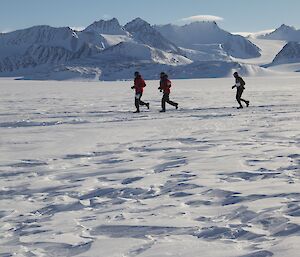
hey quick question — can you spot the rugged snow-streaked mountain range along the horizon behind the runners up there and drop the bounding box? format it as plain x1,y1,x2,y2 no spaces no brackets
0,18,300,80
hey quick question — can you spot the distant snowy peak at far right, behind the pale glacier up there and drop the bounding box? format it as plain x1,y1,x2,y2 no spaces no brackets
259,24,300,42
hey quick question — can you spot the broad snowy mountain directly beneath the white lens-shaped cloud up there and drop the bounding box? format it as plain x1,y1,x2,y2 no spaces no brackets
155,22,260,58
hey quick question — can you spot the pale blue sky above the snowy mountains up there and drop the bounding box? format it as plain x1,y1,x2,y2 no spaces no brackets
0,0,300,32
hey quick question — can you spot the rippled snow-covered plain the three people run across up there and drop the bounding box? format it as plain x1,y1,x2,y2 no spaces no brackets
0,76,300,257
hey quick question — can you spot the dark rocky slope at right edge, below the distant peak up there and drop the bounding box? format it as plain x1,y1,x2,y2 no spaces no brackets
272,42,300,65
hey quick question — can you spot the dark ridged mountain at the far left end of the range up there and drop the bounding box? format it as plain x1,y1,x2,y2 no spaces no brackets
0,26,101,72
